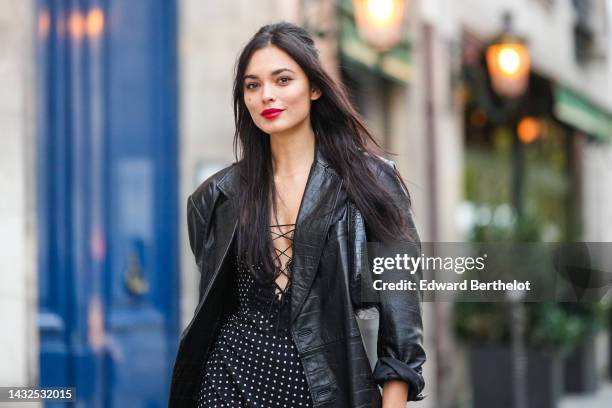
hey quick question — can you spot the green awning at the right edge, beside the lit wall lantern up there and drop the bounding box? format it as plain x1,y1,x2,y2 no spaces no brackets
555,86,612,142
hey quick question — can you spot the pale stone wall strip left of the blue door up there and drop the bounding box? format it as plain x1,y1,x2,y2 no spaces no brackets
0,0,39,398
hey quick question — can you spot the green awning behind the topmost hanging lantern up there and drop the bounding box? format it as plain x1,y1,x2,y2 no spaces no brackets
339,0,412,84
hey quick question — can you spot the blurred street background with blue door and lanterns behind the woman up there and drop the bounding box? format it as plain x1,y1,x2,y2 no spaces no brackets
0,0,612,408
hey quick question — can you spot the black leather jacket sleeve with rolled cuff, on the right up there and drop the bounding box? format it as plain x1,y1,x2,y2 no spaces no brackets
358,162,426,401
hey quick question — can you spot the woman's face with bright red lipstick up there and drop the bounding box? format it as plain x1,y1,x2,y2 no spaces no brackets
244,45,321,134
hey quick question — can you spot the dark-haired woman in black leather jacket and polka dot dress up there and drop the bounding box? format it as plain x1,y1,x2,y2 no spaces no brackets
170,23,425,408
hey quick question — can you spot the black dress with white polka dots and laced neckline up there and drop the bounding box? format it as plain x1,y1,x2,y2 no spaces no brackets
197,225,313,408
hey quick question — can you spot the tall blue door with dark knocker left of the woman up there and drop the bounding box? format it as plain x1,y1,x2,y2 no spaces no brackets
37,0,179,408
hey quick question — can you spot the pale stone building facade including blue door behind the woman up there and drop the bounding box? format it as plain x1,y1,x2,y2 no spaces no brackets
0,0,612,408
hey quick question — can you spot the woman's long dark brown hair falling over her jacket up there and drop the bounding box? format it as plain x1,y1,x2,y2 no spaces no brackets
233,22,407,284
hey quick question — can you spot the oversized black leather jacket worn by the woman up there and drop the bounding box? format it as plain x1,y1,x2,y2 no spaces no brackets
169,150,425,408
